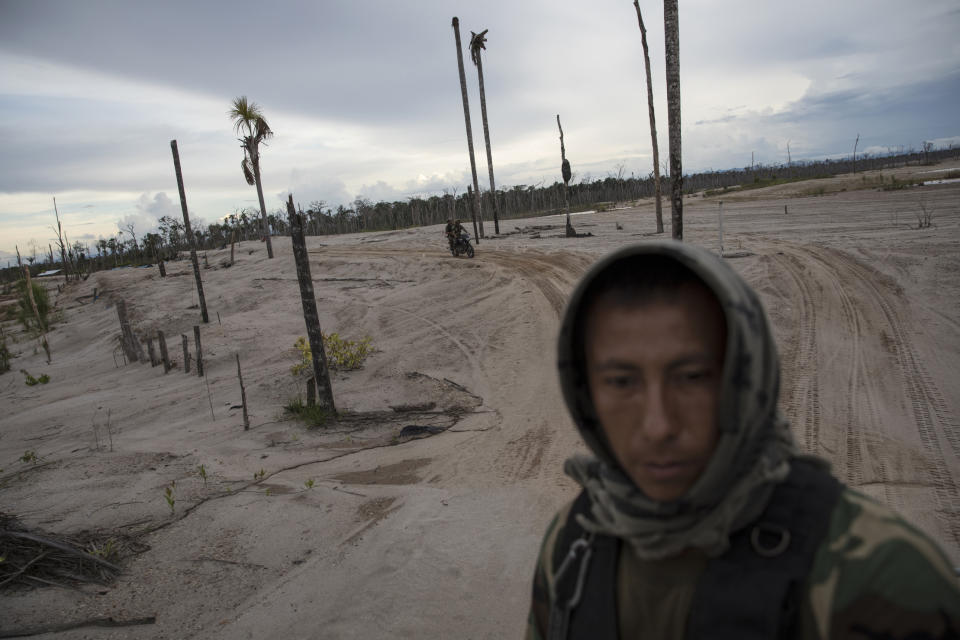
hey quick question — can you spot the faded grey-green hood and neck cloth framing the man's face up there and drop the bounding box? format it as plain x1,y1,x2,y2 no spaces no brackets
558,240,796,558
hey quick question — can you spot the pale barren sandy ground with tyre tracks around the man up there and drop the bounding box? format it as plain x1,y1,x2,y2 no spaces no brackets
0,162,960,639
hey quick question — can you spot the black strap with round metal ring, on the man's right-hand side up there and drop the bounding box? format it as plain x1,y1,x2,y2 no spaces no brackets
686,458,842,640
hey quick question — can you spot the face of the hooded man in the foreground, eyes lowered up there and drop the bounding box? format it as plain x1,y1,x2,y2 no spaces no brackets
585,285,726,502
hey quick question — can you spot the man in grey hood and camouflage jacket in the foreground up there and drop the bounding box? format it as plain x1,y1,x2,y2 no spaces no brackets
527,241,960,640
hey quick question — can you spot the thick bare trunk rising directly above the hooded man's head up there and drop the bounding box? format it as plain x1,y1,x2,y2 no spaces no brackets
663,0,683,240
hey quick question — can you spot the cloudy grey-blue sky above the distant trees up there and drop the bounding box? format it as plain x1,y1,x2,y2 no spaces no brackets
0,0,960,265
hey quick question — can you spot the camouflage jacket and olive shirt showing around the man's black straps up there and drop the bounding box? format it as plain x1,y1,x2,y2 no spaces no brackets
526,489,960,640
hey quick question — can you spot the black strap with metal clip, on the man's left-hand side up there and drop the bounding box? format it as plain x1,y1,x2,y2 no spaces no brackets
547,491,620,640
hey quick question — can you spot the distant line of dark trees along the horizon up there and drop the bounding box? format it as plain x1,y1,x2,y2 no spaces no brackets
0,143,960,282
